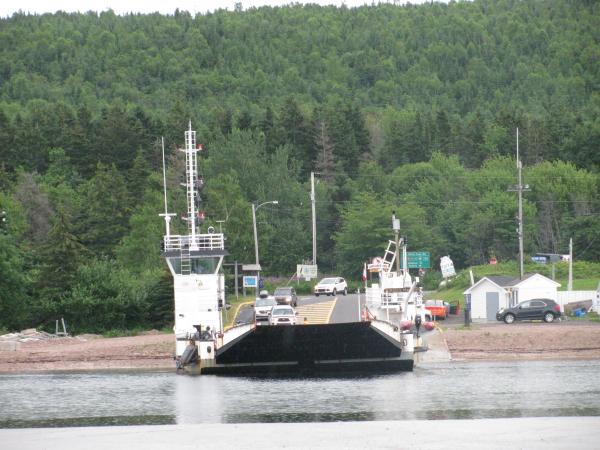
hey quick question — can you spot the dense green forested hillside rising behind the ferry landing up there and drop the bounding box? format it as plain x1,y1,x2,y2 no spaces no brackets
0,0,600,331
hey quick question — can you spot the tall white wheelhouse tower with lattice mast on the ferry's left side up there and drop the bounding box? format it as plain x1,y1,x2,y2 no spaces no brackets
161,123,227,357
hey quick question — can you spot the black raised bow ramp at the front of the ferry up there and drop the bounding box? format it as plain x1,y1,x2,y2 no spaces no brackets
189,322,413,375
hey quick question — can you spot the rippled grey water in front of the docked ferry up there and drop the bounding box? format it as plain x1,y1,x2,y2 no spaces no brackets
0,361,600,428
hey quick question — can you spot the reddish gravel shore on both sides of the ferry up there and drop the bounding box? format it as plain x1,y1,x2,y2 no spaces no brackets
0,319,600,373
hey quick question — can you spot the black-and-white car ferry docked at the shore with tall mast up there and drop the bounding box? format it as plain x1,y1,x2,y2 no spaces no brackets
160,122,414,375
